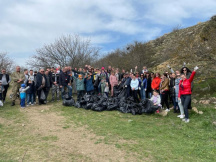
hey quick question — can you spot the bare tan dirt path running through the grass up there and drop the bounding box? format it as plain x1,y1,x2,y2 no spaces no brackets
21,105,137,162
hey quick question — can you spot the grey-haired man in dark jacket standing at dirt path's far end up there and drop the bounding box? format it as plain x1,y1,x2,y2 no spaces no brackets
36,69,47,105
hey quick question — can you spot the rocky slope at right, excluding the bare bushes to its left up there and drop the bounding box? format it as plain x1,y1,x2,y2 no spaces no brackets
147,16,216,79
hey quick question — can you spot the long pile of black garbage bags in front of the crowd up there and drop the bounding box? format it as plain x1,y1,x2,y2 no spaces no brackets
63,90,158,115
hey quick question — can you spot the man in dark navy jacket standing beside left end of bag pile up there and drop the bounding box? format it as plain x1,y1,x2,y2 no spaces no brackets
59,67,70,99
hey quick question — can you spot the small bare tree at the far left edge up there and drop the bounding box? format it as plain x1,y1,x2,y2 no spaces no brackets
0,52,14,72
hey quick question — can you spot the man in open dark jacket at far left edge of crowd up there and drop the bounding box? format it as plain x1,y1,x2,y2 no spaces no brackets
0,68,11,102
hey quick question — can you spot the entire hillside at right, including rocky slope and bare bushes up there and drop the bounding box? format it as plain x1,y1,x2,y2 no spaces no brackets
95,16,216,95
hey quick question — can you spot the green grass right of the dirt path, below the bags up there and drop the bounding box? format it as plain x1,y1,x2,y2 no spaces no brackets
52,102,216,161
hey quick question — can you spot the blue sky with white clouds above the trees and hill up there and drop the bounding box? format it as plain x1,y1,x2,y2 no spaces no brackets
0,0,216,66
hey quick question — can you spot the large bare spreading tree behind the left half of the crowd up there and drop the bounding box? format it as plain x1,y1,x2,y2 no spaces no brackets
28,35,99,68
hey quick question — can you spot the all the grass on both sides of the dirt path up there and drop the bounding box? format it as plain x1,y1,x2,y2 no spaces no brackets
0,93,216,161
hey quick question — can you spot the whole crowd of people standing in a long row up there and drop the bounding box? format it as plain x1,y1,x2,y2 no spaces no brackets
0,64,198,122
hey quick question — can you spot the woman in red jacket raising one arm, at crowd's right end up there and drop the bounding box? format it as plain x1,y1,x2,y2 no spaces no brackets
178,66,198,123
